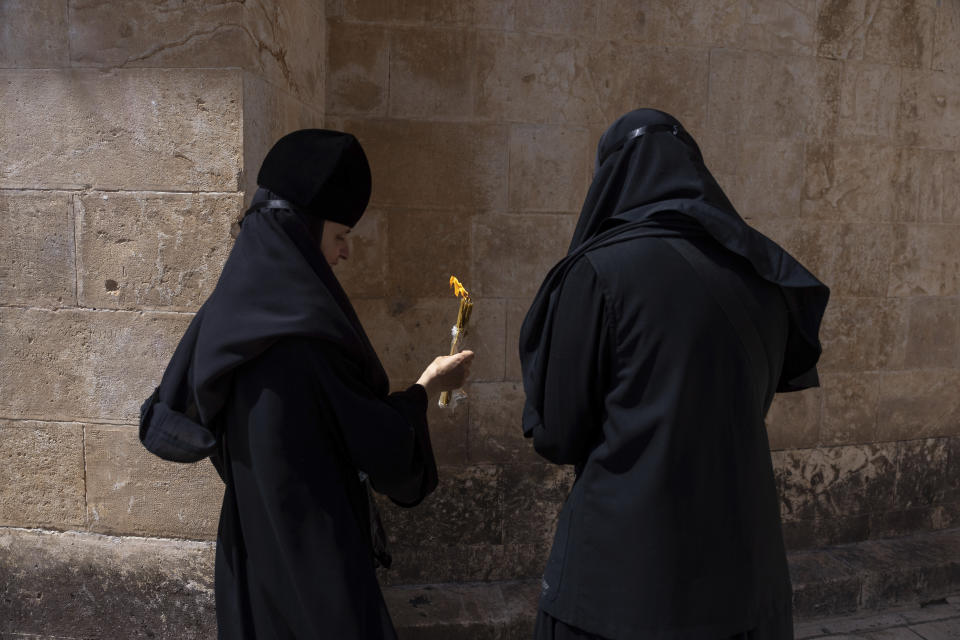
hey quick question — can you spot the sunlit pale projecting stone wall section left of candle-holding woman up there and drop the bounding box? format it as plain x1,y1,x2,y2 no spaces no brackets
0,0,326,552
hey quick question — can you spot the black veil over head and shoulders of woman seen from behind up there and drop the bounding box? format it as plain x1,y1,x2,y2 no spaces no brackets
520,109,830,432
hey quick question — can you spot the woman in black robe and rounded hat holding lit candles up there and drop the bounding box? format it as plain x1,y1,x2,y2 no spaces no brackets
140,129,470,640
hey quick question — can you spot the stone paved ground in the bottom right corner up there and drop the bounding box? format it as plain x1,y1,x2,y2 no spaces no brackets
795,594,960,640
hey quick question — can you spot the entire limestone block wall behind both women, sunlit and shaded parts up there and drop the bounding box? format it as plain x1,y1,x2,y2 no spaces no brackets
0,0,960,637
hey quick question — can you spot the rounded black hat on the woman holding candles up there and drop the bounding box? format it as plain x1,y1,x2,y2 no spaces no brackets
257,129,370,227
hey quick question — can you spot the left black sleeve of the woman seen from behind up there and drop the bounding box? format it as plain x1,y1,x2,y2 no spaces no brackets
533,258,611,465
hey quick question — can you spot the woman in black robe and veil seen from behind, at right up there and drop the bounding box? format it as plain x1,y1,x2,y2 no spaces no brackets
520,109,829,640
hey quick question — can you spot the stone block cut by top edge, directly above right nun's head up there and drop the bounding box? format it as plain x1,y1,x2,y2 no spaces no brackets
598,0,743,47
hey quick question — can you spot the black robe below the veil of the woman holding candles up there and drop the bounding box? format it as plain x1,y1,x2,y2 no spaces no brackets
216,338,436,639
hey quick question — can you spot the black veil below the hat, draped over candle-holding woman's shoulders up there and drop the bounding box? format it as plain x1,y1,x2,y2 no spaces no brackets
140,140,389,462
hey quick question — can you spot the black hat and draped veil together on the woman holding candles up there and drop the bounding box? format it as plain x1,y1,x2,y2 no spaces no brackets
140,129,389,462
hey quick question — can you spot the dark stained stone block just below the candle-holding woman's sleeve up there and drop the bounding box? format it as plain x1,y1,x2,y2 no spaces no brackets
378,465,503,552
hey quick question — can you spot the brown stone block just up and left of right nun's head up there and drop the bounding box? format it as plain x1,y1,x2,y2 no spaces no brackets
476,33,599,124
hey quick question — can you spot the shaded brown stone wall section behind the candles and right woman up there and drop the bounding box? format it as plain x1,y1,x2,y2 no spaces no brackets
326,0,960,584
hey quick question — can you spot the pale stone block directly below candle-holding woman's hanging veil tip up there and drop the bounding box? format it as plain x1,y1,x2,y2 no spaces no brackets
84,426,223,540
